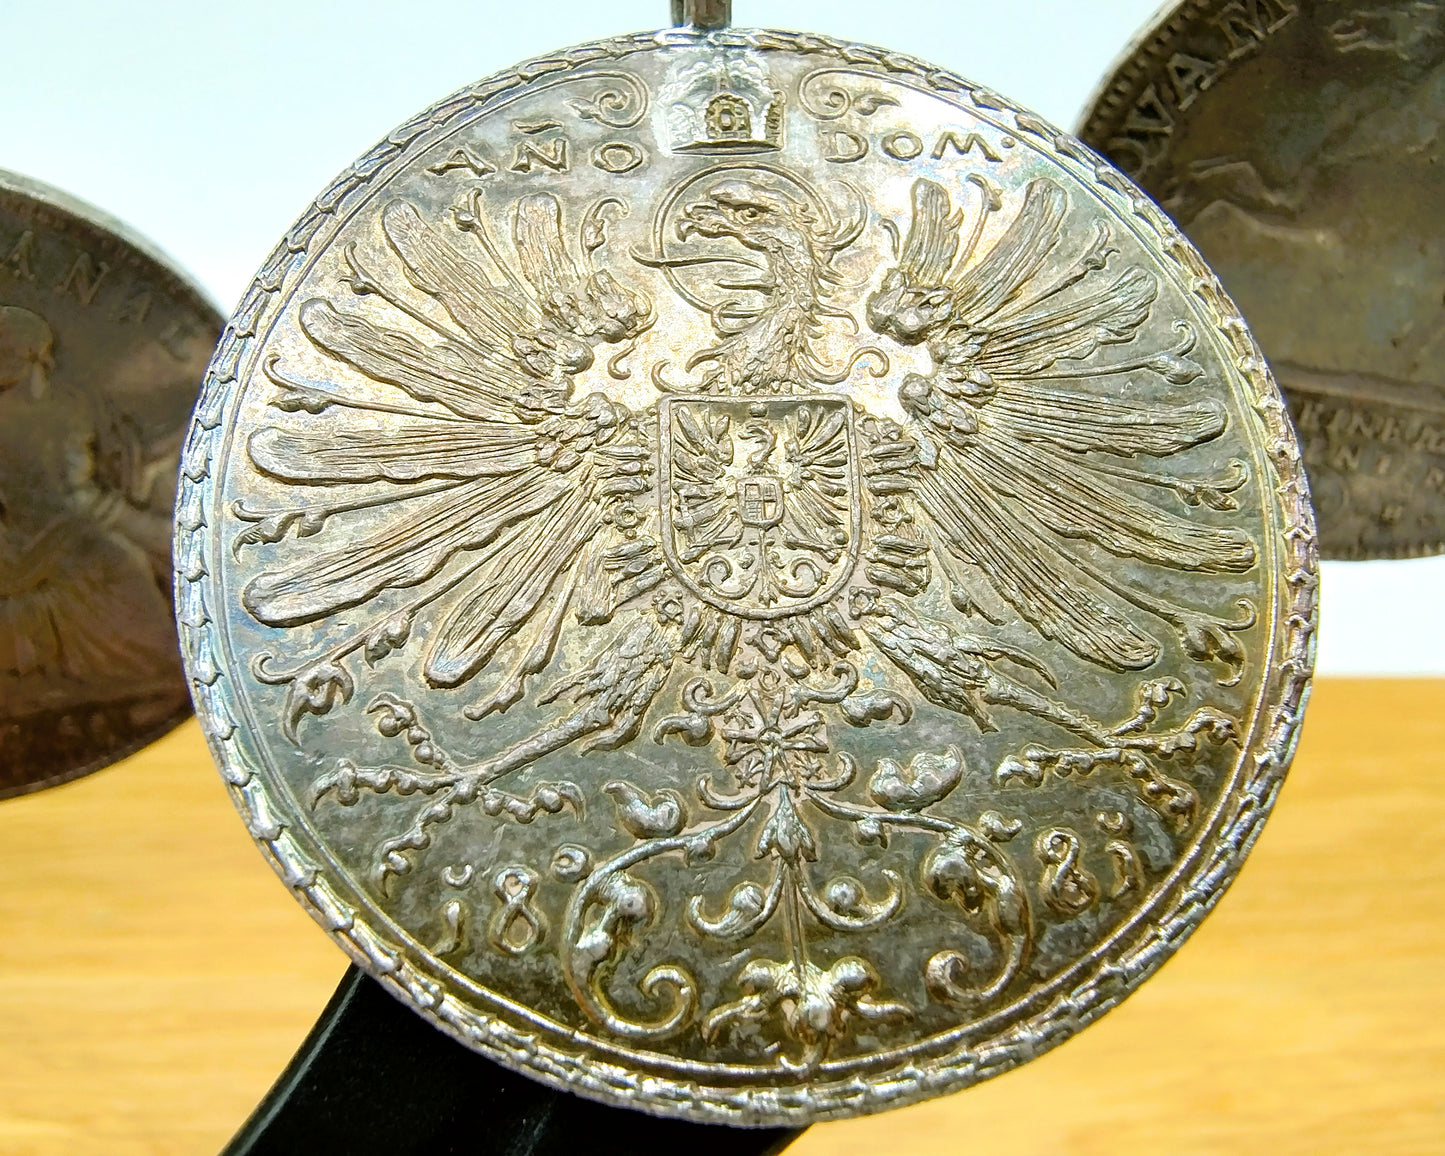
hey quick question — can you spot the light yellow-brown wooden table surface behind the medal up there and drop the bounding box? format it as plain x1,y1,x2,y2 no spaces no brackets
0,679,1445,1156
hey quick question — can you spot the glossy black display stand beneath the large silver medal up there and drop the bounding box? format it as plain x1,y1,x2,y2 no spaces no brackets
223,967,799,1156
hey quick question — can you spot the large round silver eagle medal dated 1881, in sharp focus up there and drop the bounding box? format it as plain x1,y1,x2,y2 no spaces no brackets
176,30,1315,1124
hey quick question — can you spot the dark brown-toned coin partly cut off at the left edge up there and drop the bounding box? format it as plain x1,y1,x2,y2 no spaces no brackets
0,172,220,798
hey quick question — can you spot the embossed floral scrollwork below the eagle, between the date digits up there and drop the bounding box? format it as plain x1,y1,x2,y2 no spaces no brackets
562,662,1030,1069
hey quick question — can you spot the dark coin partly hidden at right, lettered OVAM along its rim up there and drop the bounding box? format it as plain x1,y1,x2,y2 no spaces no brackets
1079,0,1445,558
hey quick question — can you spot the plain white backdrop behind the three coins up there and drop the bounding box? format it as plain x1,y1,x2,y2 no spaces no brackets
0,0,1445,673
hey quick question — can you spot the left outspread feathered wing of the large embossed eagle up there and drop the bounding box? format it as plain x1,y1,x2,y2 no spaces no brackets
243,194,652,686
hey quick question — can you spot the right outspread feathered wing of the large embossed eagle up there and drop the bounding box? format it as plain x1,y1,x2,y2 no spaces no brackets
867,179,1254,670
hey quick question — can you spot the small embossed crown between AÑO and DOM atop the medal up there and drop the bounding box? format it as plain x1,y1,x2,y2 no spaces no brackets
659,53,785,153
